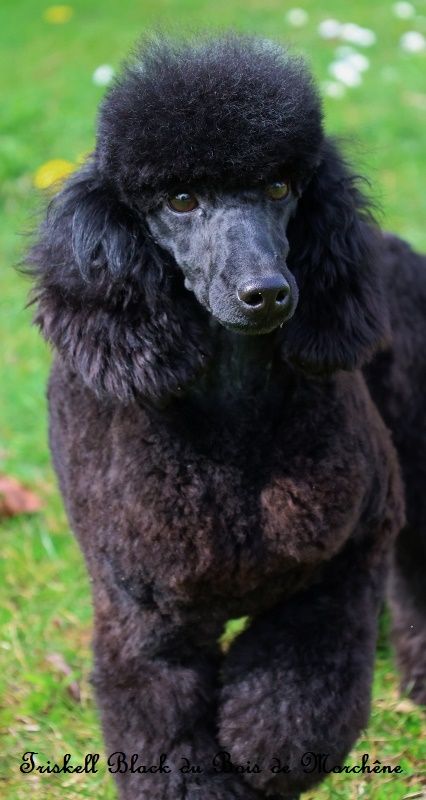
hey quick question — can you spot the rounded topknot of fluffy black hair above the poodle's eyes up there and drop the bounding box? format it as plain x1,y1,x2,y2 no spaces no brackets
95,35,323,205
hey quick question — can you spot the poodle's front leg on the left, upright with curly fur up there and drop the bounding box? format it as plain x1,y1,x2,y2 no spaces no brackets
93,581,259,800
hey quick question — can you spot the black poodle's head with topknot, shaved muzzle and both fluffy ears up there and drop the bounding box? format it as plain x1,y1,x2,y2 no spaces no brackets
29,36,385,403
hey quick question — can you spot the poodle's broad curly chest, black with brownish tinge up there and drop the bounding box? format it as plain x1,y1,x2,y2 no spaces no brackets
51,366,360,613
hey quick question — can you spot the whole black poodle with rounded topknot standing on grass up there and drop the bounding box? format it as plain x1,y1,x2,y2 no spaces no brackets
30,36,426,800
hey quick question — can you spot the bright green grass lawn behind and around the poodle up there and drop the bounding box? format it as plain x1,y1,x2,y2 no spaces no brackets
0,0,426,800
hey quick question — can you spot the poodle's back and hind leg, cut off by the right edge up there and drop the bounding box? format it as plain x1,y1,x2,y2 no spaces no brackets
365,236,426,703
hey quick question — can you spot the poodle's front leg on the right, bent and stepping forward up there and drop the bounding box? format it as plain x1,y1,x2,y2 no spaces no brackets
218,544,384,798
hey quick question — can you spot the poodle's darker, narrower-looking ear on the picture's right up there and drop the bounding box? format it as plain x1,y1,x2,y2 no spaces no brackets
283,141,388,373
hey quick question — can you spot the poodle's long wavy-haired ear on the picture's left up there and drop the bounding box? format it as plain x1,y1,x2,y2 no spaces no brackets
28,164,208,404
